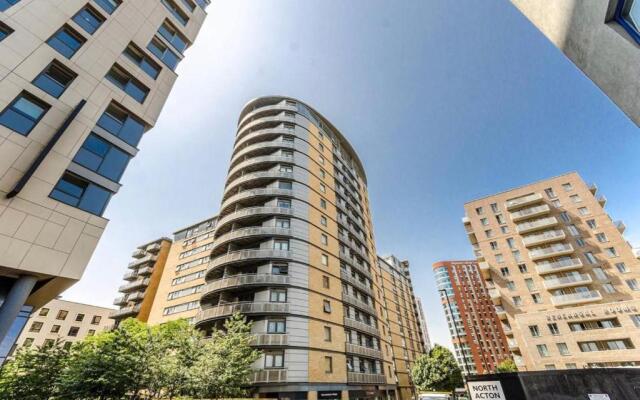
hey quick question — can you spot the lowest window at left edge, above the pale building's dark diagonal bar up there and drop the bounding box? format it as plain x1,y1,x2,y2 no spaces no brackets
0,92,49,136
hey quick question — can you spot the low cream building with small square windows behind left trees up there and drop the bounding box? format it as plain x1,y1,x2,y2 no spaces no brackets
11,299,114,349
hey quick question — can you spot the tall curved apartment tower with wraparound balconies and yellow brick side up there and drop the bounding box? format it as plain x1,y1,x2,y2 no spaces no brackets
195,96,396,399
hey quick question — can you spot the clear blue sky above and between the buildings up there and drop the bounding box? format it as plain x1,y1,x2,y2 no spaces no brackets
64,0,640,350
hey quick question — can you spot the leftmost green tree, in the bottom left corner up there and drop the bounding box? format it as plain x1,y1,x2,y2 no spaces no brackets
0,341,69,400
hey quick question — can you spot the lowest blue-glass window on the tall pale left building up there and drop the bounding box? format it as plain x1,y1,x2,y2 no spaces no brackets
49,171,111,215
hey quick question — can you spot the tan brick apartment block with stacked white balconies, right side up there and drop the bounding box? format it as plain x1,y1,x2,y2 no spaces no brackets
463,173,640,370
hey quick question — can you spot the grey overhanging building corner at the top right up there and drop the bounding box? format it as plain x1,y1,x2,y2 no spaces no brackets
511,0,640,125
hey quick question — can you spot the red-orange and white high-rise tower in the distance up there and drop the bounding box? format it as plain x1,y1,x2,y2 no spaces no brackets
433,260,511,375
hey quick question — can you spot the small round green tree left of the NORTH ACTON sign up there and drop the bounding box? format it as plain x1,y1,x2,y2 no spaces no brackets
411,344,463,392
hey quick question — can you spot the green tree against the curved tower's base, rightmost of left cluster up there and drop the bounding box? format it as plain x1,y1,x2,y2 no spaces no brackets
193,313,260,398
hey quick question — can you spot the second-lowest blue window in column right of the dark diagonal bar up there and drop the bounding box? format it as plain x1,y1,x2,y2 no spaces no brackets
73,133,131,182
